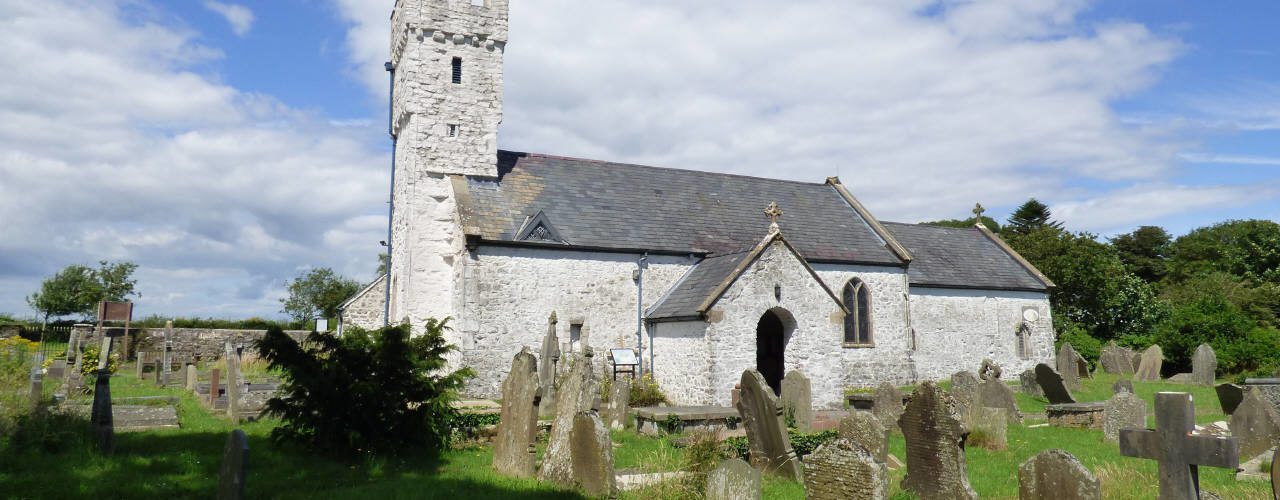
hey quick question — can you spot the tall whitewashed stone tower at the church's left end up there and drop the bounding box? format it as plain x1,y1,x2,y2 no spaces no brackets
388,0,507,327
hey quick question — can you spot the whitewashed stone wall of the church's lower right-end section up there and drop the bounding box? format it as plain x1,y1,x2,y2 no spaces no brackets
911,288,1053,380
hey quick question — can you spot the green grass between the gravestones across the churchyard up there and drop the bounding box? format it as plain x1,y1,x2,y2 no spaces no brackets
0,368,1270,500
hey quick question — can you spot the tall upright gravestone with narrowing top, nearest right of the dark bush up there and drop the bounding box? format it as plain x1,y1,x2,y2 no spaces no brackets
493,348,540,477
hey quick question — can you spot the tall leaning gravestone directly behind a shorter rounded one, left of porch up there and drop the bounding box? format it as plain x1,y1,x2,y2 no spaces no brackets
538,347,599,487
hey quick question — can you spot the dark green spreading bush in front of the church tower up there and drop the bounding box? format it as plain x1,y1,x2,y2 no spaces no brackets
257,318,472,457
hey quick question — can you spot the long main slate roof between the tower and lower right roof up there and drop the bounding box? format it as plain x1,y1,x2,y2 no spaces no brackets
460,151,904,266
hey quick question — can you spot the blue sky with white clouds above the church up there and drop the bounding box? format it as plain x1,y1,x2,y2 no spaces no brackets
0,0,1280,317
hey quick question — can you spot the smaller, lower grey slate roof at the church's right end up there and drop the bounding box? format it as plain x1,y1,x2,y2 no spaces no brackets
881,223,1047,292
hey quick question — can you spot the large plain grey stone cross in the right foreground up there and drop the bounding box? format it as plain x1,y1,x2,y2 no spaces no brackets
1120,393,1240,500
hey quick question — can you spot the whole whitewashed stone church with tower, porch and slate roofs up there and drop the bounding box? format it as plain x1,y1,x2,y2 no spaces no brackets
342,0,1053,408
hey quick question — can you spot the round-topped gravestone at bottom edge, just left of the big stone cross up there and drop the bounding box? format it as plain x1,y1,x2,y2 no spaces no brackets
1018,450,1102,500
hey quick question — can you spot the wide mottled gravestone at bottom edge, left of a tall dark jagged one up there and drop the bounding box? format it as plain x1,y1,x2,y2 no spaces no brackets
804,437,888,500
